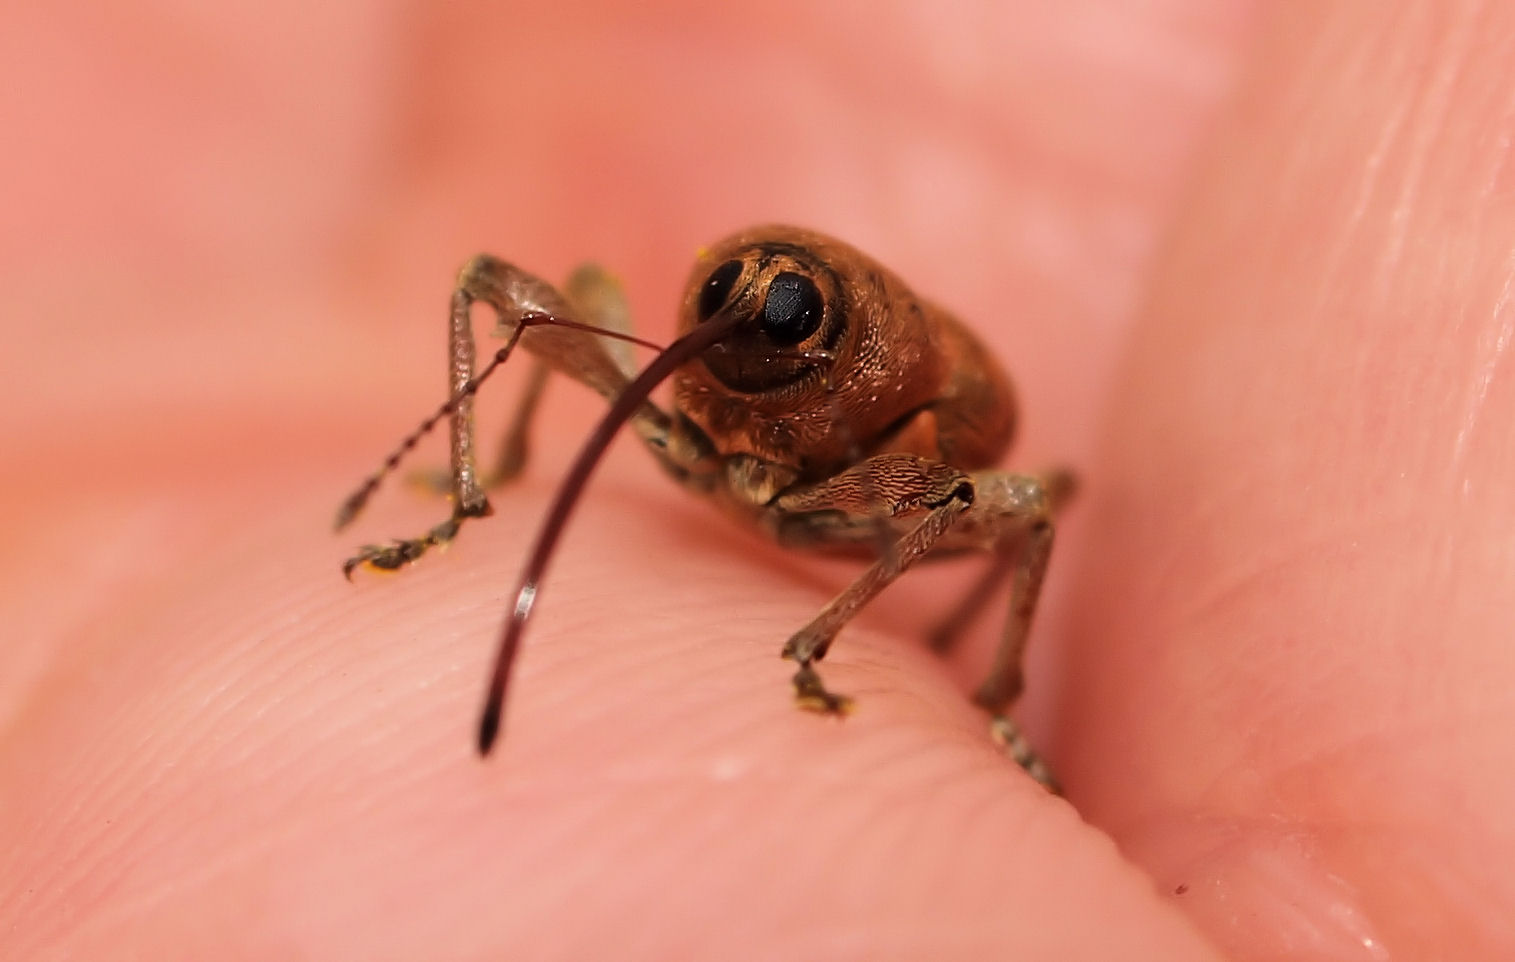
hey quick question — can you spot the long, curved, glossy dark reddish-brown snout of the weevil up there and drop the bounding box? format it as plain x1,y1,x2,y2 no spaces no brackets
479,312,738,756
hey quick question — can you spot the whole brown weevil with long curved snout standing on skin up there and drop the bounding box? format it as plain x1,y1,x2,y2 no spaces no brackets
336,226,1073,786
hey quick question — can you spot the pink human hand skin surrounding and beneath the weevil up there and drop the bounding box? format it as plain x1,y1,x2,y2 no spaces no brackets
0,0,1515,959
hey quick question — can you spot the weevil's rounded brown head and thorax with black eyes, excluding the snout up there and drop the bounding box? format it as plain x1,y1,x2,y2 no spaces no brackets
676,226,945,468
